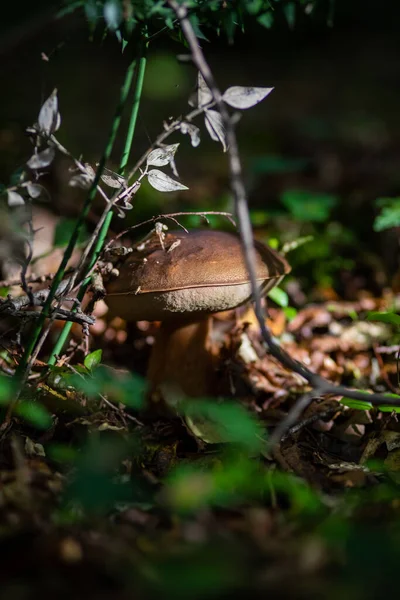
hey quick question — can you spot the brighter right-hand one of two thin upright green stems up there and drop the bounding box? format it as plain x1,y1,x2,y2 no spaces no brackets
48,36,148,365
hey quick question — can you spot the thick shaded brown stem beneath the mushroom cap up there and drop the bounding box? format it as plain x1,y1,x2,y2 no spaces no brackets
147,315,215,404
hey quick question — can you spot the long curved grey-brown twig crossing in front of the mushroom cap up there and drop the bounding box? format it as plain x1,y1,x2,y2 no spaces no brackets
168,0,400,436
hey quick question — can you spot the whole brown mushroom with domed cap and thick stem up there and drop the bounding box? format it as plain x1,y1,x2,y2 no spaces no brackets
106,230,290,401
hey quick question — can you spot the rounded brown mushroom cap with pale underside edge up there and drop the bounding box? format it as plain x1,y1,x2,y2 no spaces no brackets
105,230,290,321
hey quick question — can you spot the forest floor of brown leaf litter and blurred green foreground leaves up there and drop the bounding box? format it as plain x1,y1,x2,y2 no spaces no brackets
0,284,400,600
